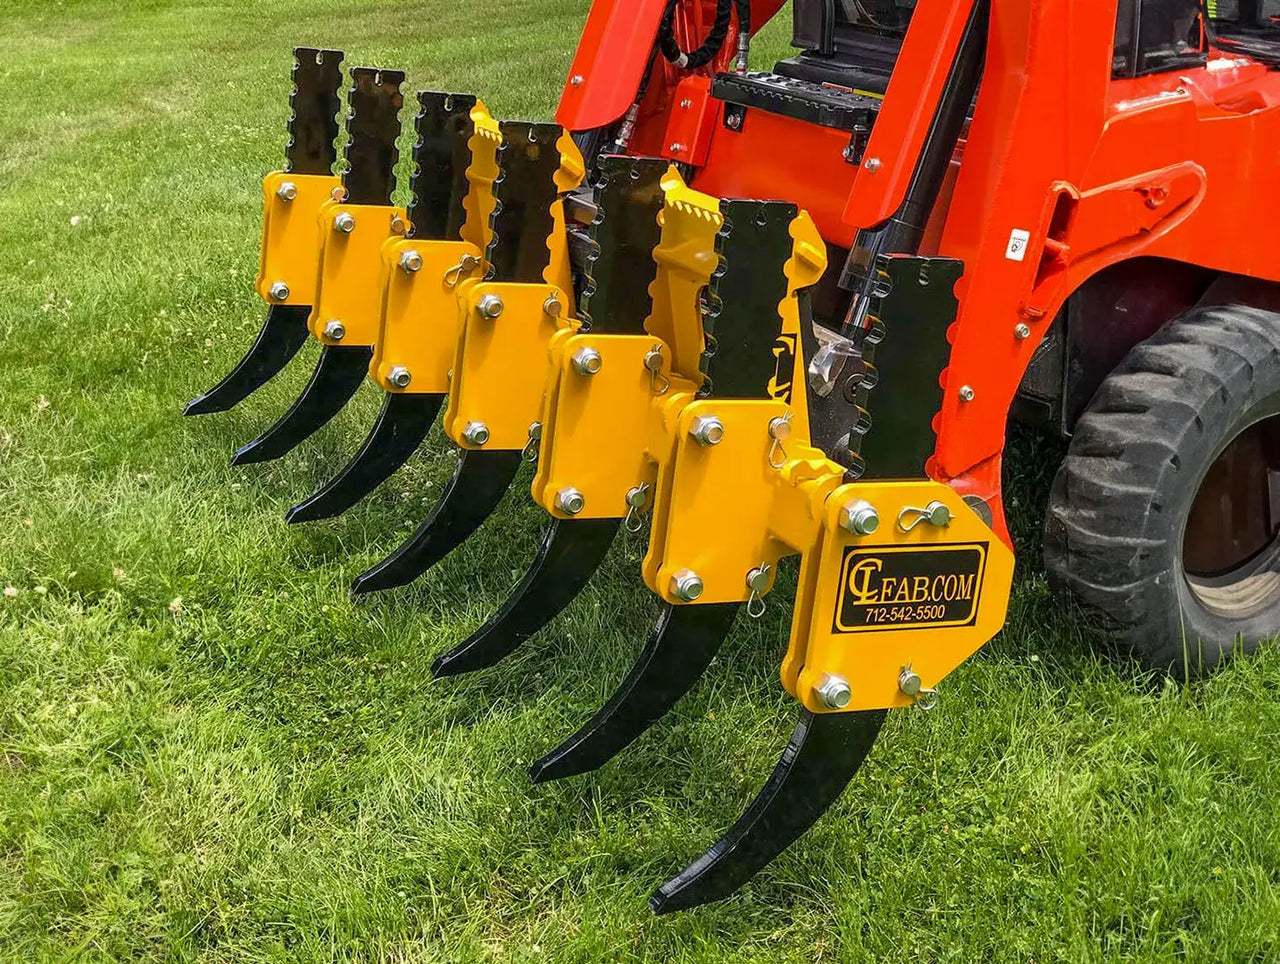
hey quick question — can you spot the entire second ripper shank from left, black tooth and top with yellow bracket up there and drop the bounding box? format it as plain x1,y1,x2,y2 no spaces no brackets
232,67,407,465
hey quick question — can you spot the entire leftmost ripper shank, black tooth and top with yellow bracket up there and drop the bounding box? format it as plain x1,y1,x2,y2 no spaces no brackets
183,47,343,415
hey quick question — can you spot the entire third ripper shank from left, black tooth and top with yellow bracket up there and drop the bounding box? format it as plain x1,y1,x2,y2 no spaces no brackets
287,91,497,522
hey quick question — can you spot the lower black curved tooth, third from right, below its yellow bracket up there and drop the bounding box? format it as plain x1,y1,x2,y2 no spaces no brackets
431,518,622,679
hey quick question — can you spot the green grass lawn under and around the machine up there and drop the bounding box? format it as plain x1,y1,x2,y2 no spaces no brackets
0,0,1280,964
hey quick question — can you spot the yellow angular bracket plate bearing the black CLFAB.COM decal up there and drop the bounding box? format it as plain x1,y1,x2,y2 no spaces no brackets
782,480,1014,713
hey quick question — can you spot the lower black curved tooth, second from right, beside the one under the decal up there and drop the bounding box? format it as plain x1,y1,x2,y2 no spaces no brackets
529,603,740,783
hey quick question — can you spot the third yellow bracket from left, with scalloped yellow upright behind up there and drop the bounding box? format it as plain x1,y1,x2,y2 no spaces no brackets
369,105,502,394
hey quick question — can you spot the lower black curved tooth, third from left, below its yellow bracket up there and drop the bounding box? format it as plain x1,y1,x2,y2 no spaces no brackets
285,392,444,522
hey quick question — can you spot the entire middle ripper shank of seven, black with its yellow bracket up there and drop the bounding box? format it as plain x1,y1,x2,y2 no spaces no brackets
352,122,584,595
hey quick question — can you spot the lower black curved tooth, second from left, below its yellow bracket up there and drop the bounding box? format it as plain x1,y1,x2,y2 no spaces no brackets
232,344,374,465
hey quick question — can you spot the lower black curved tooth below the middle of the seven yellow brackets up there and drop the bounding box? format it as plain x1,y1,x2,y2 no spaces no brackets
351,449,522,595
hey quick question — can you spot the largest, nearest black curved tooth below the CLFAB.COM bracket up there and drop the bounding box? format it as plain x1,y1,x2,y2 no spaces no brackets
649,709,887,914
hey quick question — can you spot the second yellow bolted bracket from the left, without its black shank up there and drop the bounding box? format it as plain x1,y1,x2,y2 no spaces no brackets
307,201,408,344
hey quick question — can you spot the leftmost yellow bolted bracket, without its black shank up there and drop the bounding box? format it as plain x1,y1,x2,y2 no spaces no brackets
257,170,342,305
